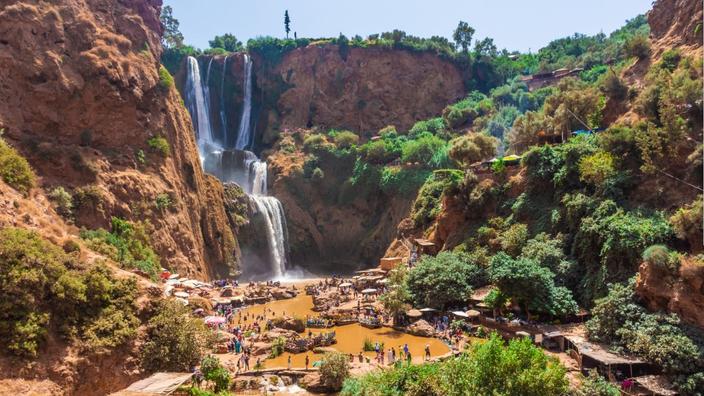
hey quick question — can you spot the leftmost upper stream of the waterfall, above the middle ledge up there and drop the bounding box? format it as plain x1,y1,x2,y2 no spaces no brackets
185,56,219,152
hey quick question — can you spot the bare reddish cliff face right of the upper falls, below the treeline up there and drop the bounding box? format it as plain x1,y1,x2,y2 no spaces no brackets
255,45,465,143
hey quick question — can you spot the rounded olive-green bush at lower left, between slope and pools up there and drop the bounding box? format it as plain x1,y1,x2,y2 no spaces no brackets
141,300,213,372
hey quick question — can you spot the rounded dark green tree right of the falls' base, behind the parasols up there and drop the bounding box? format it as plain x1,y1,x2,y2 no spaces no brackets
406,252,486,308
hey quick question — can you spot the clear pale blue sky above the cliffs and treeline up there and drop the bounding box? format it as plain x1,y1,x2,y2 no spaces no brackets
164,0,651,51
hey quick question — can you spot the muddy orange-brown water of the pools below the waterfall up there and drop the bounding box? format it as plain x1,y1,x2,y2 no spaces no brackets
235,286,450,368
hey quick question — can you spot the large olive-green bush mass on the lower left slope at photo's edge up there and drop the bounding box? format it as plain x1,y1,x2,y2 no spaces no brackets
0,228,139,358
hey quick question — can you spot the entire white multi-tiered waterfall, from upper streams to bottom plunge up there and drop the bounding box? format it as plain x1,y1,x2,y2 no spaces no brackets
185,54,288,278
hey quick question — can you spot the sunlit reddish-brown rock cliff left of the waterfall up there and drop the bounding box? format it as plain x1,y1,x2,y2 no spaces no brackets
0,0,238,278
